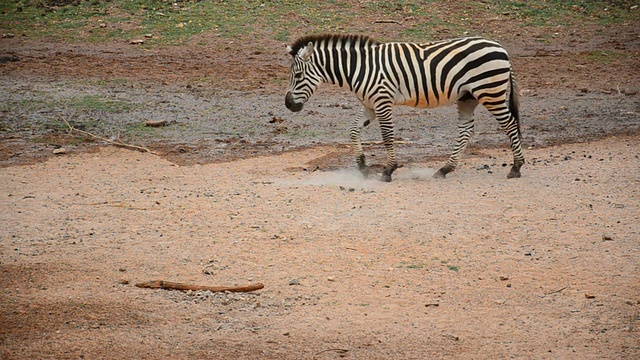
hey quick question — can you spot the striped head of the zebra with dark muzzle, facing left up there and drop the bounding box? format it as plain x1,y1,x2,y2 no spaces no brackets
284,42,322,112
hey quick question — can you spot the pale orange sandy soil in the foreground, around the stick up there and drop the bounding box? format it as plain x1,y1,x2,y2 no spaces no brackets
0,136,640,359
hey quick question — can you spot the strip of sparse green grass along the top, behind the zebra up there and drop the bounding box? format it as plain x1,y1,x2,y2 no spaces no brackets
0,0,638,46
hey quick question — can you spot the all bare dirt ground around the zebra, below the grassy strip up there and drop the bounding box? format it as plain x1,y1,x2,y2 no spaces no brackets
0,8,640,359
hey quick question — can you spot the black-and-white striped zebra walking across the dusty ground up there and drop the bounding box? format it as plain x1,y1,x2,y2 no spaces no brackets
285,34,524,182
